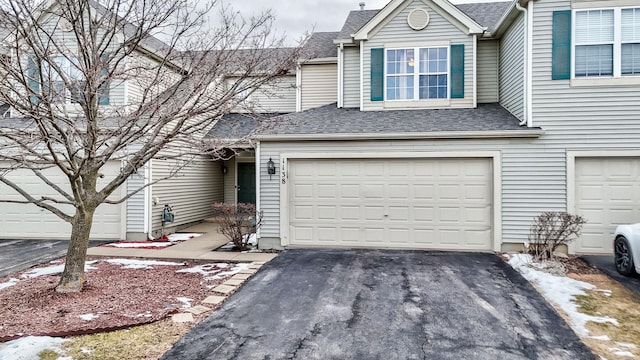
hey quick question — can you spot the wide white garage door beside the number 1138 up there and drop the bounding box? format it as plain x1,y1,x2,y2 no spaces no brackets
288,158,492,250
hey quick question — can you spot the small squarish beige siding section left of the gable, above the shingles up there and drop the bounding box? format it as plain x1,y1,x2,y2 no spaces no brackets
300,64,338,110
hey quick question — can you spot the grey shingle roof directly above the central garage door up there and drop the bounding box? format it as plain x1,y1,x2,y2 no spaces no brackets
255,103,531,135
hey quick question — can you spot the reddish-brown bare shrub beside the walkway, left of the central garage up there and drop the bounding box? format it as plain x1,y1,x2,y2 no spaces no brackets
212,203,262,251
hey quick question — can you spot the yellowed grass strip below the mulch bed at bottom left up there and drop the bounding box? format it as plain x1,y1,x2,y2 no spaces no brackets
62,319,191,360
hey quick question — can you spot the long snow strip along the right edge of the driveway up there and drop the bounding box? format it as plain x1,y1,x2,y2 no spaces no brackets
509,254,618,336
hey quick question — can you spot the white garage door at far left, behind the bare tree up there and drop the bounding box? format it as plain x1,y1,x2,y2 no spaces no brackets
0,161,122,239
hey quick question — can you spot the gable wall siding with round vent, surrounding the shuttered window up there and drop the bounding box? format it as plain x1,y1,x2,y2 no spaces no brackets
363,0,474,110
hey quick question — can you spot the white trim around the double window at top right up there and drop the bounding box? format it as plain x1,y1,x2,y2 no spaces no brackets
571,6,640,79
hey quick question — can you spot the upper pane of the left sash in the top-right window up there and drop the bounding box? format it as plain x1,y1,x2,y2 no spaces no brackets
575,10,613,44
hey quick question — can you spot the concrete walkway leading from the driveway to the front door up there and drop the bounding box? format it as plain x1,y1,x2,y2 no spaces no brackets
87,222,277,262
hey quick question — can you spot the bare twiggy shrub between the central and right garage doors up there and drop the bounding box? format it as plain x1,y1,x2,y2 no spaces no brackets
529,211,586,260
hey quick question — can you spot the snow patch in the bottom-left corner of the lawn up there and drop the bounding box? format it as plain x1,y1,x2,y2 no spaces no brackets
0,336,71,360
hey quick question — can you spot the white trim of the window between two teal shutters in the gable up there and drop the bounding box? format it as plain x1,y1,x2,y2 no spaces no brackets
383,44,451,102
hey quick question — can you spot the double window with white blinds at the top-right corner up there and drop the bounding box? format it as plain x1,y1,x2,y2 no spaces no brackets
574,8,640,78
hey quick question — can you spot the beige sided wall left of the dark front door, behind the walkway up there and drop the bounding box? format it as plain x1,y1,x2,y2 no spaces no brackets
151,156,224,237
